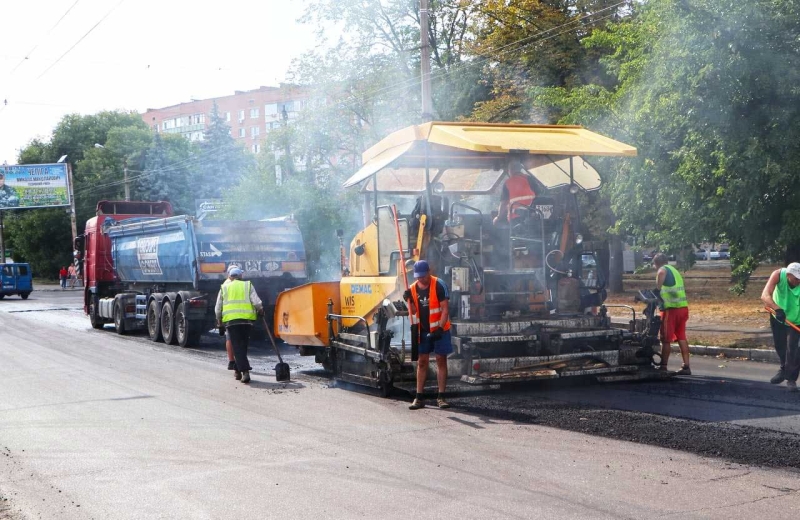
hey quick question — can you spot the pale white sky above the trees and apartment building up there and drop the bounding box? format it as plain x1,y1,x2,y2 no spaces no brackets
0,0,315,164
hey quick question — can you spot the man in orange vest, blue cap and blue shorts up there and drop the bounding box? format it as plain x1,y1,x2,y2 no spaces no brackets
403,260,453,410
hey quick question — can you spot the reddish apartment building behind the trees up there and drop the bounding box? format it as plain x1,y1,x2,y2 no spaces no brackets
142,84,310,153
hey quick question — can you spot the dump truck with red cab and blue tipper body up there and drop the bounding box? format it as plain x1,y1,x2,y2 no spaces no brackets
76,201,306,347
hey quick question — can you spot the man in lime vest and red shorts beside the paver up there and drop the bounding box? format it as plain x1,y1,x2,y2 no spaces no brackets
653,253,692,376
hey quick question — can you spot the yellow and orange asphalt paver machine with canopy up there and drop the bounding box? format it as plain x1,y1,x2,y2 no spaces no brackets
274,122,664,393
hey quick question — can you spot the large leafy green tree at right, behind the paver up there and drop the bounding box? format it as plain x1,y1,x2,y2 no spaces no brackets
533,0,800,291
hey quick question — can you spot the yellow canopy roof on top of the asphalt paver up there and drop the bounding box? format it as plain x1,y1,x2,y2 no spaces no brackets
344,122,636,193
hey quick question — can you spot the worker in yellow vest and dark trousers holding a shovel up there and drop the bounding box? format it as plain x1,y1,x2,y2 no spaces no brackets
214,267,264,383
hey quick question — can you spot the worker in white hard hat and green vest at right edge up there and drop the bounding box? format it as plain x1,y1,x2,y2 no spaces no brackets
761,262,800,392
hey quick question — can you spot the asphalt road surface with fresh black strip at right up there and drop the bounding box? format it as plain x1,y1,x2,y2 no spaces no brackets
0,291,800,519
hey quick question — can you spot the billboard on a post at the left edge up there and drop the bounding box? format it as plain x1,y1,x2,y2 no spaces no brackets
0,163,69,209
